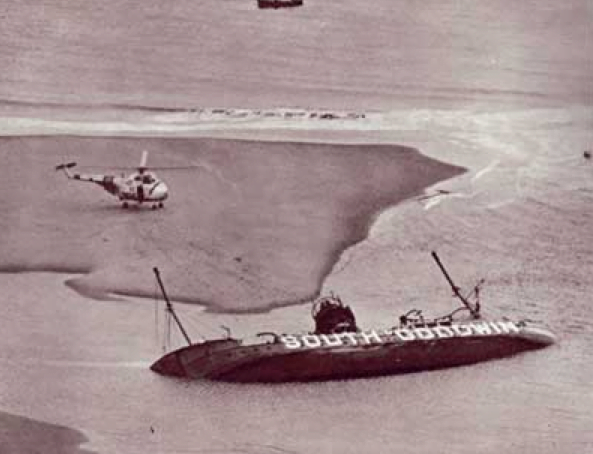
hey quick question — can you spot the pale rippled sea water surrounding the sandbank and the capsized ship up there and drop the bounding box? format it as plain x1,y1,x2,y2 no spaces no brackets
0,0,593,454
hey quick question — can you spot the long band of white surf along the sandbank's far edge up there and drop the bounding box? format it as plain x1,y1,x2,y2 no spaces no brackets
0,107,592,143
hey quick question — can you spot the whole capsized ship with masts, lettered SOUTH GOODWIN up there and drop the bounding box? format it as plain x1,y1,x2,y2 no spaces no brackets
151,252,555,383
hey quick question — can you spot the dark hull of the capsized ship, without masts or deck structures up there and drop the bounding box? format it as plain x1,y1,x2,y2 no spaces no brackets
151,322,554,382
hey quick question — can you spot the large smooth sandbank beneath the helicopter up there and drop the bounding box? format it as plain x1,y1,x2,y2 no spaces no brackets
0,136,463,312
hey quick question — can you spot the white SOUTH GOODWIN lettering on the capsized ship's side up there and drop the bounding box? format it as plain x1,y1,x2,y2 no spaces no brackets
280,320,521,350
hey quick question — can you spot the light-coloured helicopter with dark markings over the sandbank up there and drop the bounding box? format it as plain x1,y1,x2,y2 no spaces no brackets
56,150,169,210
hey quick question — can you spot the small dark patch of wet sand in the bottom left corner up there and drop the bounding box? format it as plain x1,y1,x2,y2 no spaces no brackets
0,412,93,454
